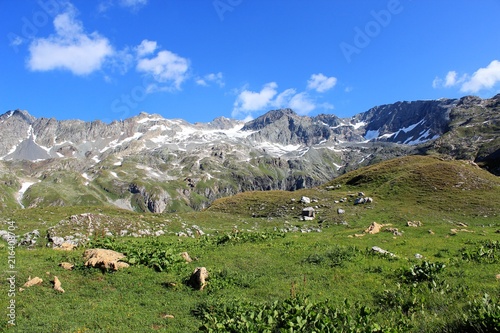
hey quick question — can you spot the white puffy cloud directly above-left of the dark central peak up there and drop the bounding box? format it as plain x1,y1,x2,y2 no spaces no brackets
232,82,278,117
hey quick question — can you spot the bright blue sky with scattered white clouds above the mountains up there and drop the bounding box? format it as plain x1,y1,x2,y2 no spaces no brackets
0,0,500,123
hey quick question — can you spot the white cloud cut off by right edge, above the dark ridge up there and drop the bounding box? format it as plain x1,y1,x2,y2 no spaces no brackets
432,60,500,93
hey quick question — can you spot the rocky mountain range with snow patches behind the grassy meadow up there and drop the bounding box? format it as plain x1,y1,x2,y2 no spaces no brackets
0,94,500,213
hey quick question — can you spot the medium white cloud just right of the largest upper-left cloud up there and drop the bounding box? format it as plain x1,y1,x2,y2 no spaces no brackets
136,50,189,90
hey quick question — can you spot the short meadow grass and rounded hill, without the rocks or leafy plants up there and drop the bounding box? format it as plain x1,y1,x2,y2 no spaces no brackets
0,156,500,332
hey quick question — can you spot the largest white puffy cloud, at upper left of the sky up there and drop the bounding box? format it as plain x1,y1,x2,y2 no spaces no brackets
27,7,114,75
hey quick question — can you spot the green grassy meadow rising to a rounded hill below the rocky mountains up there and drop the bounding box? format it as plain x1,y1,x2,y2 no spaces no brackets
0,156,500,332
